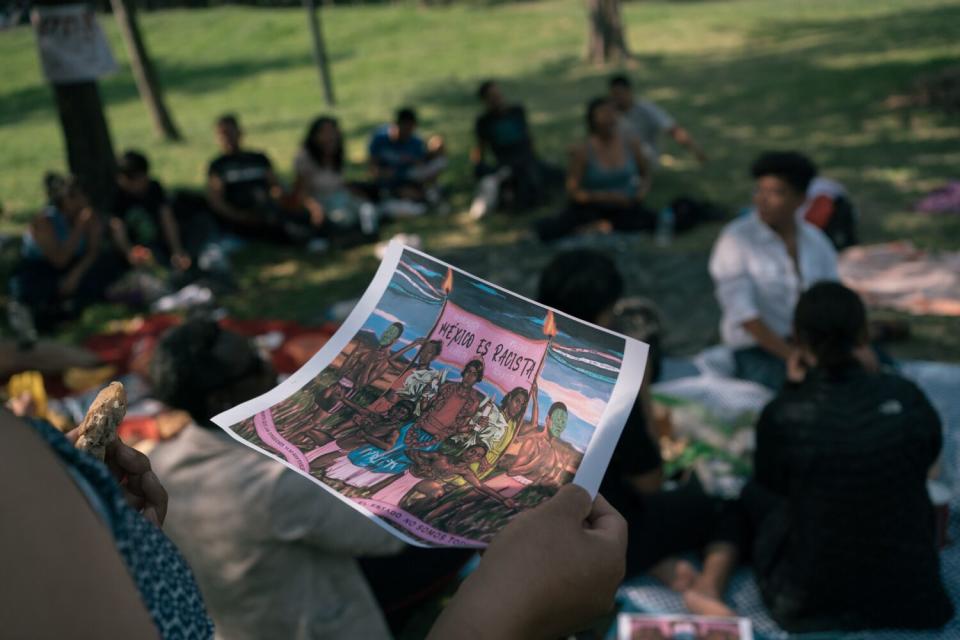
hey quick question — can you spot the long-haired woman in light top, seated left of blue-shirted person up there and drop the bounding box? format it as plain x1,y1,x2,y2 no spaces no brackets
293,116,377,242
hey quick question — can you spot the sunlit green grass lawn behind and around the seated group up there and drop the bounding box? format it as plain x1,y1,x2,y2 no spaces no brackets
0,0,960,360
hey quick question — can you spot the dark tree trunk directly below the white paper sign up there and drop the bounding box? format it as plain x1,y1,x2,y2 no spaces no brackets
53,82,117,209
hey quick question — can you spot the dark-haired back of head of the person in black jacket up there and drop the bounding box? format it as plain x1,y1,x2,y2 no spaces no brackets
793,282,868,371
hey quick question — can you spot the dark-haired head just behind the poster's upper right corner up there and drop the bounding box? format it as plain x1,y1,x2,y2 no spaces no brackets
537,249,624,325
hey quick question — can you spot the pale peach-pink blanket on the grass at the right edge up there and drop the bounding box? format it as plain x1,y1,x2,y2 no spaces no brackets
839,242,960,316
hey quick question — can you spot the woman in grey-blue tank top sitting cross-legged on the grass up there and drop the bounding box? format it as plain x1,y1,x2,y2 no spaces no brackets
536,97,656,242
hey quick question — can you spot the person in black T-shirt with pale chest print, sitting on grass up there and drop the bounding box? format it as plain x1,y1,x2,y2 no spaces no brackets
207,114,323,242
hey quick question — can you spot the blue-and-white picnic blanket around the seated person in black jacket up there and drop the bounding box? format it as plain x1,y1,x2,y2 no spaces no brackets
608,356,960,640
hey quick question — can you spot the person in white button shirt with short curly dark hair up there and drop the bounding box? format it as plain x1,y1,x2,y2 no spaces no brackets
710,151,838,390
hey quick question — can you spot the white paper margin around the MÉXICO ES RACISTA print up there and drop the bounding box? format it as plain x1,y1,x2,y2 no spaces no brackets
211,240,649,548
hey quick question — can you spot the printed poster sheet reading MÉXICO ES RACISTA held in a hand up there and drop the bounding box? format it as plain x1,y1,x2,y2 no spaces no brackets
213,243,647,547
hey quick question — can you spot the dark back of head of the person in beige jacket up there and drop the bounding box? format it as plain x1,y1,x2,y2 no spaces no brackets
150,320,275,426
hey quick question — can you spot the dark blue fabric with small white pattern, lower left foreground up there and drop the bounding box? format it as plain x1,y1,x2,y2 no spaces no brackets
32,421,213,640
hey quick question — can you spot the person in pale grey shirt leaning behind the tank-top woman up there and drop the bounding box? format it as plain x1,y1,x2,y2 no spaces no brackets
610,74,707,167
